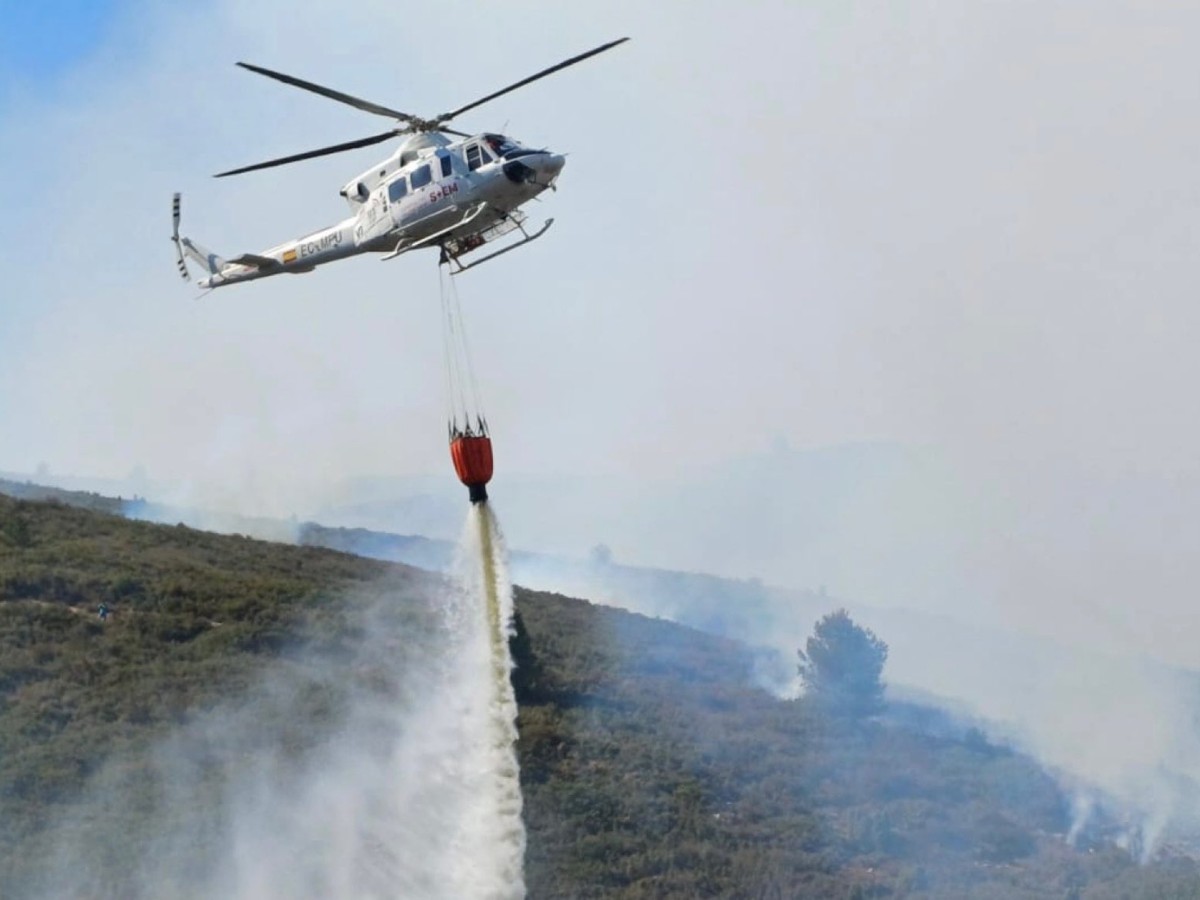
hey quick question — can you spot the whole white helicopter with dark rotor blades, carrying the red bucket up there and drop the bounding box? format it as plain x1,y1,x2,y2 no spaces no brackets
172,37,629,289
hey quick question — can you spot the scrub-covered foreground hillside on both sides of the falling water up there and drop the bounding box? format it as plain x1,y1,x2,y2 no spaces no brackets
0,497,1200,898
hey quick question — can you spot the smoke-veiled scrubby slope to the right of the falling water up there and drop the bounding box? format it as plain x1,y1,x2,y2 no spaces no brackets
520,594,1200,899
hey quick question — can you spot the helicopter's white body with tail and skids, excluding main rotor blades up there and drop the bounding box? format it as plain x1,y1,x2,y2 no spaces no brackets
175,133,565,288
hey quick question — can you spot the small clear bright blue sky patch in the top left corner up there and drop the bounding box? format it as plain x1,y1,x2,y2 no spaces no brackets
0,0,123,85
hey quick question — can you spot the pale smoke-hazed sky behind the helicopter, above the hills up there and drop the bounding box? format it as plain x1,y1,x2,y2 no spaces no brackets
0,0,1200,661
